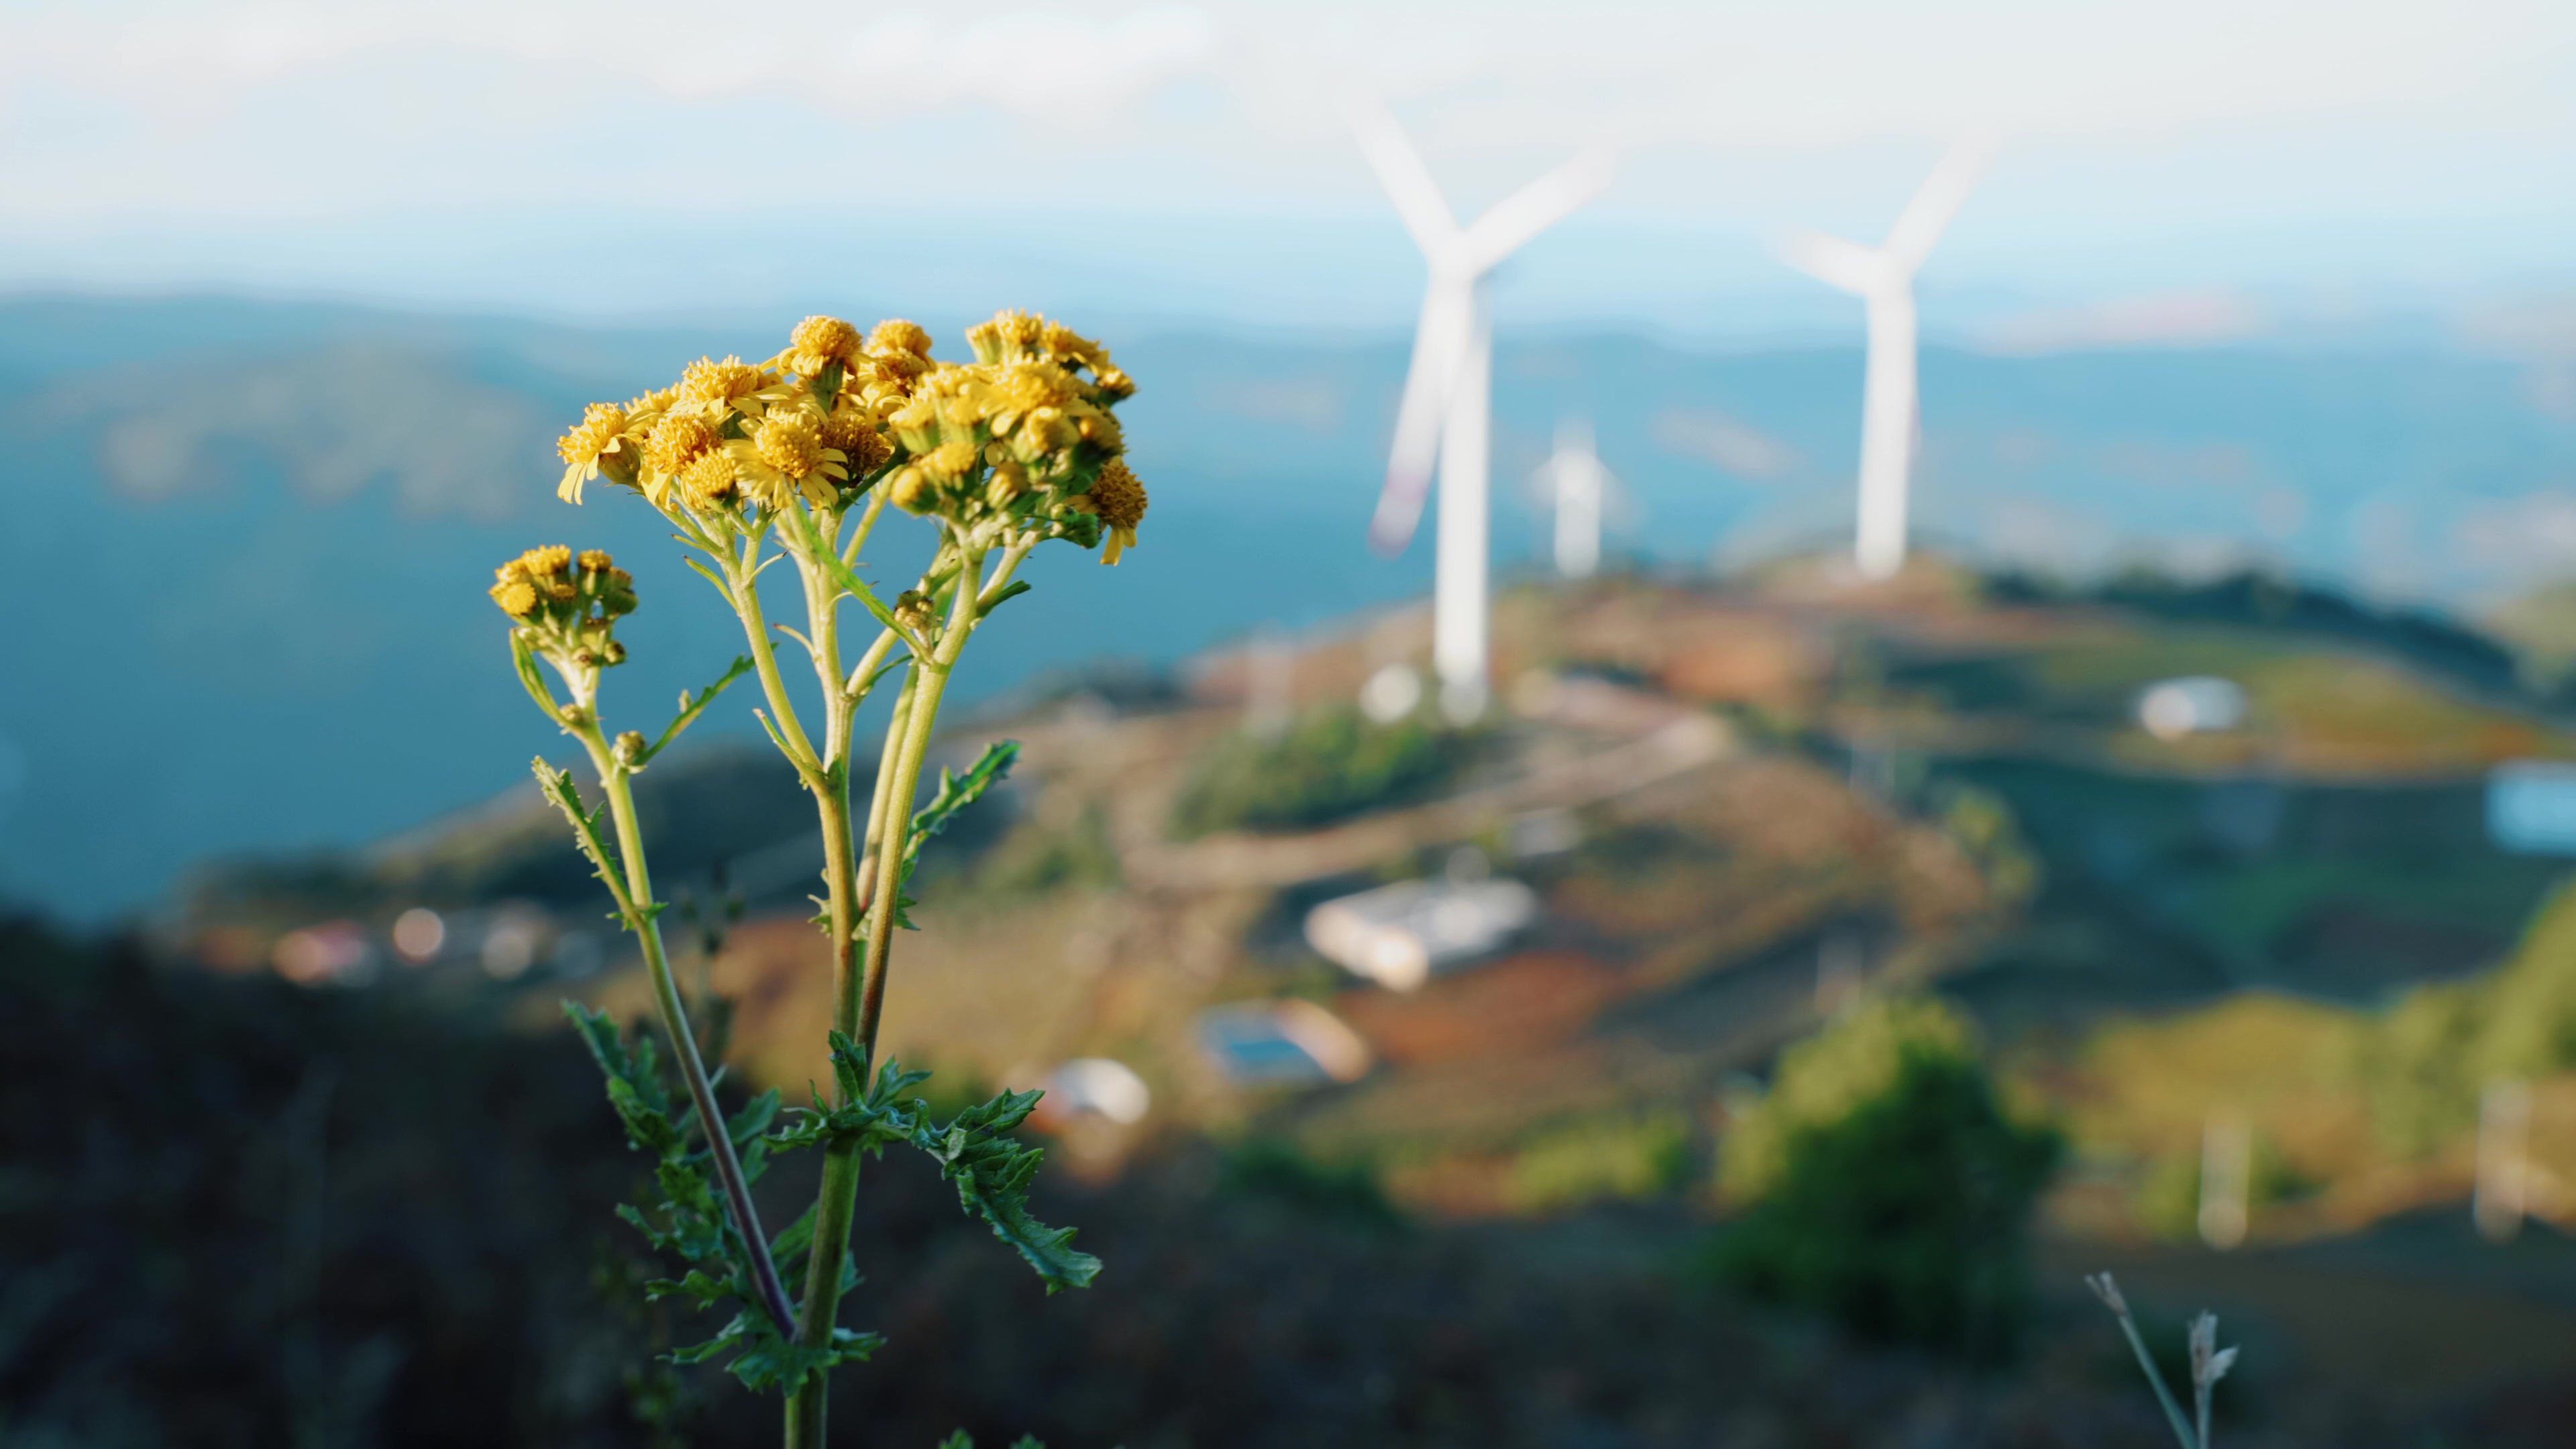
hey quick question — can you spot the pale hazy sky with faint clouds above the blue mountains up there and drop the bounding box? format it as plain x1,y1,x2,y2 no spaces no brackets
0,0,2576,332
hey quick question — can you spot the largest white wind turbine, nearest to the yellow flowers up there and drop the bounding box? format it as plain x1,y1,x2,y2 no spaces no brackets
1352,103,1610,724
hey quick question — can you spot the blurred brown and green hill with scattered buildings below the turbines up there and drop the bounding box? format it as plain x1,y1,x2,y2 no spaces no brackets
172,559,2576,1212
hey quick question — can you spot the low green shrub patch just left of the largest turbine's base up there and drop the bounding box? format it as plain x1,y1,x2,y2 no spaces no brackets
1172,706,1456,841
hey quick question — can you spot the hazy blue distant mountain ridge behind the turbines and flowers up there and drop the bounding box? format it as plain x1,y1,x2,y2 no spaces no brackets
0,297,2576,918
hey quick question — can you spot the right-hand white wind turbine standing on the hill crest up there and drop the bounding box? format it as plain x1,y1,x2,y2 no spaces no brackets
1780,140,1994,578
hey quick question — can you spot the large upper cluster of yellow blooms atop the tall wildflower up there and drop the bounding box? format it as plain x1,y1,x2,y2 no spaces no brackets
559,312,1144,562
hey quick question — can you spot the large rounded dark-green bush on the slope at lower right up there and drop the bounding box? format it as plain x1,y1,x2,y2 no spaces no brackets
1713,1000,2058,1358
